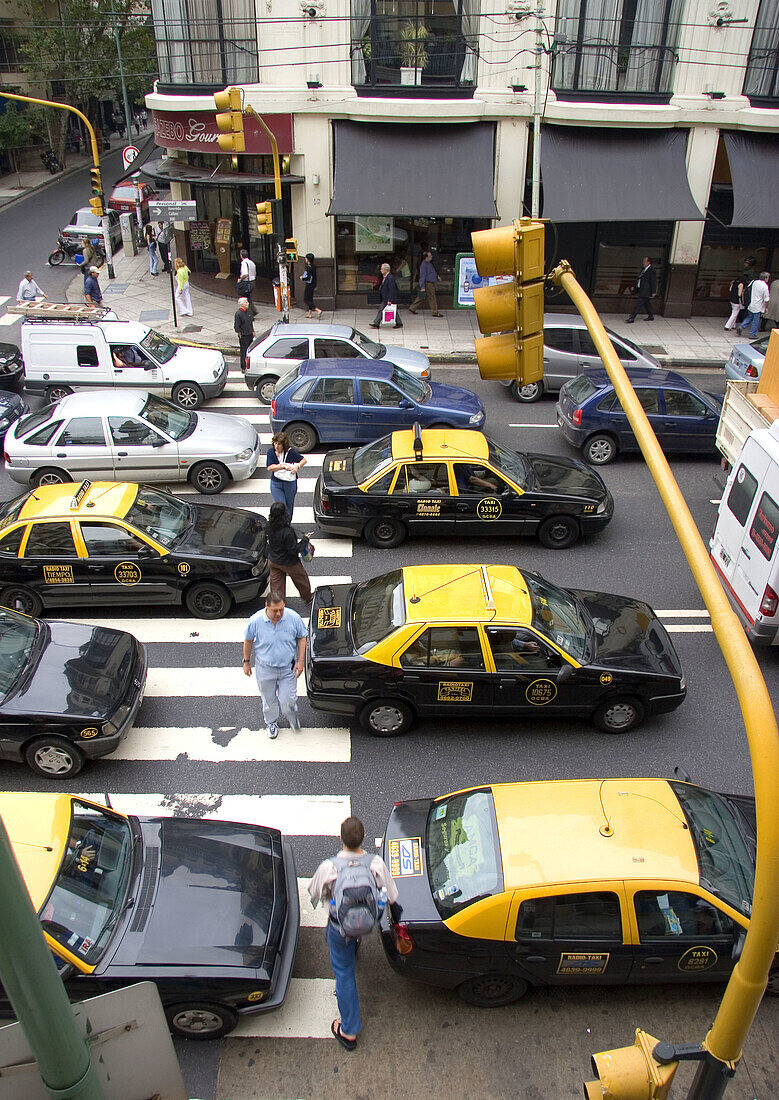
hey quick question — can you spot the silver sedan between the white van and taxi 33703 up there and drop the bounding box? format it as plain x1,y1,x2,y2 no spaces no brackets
3,389,260,494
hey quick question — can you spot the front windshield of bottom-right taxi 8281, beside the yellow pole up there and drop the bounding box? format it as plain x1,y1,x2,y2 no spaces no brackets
671,783,755,916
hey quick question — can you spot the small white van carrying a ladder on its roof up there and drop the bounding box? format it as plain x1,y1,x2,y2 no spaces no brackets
22,318,228,409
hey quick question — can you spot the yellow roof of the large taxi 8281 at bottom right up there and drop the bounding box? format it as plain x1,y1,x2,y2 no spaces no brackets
492,779,700,890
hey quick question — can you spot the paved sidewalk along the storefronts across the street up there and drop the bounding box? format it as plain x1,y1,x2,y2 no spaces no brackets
67,239,738,367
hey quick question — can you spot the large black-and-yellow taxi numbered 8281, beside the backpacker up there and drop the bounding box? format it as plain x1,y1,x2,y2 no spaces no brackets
382,779,779,1008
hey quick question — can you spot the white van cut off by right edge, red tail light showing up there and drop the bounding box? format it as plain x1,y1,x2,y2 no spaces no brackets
710,421,779,646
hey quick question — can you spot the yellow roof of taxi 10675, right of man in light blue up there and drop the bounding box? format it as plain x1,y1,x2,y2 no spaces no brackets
403,565,533,626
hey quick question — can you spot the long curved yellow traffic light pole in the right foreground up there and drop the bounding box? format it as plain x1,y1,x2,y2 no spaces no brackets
548,261,779,1100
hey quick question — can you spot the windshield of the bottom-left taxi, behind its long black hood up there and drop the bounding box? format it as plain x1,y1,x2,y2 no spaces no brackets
39,800,133,966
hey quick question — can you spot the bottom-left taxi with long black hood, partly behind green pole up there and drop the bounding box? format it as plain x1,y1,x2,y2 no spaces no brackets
0,794,300,1040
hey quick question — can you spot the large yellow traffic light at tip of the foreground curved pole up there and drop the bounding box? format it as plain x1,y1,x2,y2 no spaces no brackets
471,218,544,386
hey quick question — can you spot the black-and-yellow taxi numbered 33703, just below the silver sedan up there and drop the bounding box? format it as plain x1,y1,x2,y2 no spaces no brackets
0,481,267,619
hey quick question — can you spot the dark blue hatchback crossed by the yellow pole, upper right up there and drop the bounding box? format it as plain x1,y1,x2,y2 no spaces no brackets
557,367,723,466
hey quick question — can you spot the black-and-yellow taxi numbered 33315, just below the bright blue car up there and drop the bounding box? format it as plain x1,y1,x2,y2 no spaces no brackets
314,424,614,550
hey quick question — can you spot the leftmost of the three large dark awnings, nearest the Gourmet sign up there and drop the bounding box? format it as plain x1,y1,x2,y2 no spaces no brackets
328,120,497,218
